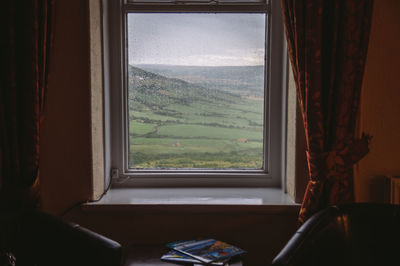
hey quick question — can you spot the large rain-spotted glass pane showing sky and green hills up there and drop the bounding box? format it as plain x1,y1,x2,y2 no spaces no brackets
128,13,265,169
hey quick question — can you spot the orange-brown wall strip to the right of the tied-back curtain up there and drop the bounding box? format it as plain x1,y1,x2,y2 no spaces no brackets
355,0,400,202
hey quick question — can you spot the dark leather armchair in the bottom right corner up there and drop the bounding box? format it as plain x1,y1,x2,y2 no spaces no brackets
272,203,400,266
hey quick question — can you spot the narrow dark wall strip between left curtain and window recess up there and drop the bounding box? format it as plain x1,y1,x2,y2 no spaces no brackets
40,0,93,214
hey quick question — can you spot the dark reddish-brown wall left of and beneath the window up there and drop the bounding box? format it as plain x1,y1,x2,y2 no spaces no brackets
40,0,298,265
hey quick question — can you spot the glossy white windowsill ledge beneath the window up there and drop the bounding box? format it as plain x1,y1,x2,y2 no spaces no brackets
82,188,299,213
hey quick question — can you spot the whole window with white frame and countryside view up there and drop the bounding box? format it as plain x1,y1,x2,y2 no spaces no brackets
103,0,286,186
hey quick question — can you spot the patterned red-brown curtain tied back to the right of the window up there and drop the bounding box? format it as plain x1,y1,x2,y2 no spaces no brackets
282,0,373,223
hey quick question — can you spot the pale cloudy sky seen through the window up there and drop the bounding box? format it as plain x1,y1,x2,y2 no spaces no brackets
128,13,265,66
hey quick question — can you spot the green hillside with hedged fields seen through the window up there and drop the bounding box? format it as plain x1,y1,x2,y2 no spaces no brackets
129,66,264,169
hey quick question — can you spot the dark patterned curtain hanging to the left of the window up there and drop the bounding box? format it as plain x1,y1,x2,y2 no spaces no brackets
0,0,53,209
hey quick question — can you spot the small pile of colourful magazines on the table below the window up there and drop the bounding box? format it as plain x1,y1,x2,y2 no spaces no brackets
168,239,245,264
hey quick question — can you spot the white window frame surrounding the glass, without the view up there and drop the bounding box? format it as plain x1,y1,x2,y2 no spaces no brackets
102,0,287,188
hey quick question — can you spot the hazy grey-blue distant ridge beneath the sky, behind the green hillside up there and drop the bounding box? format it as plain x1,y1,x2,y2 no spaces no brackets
135,64,265,97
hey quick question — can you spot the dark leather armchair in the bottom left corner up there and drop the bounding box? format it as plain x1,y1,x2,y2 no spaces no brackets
0,210,122,266
